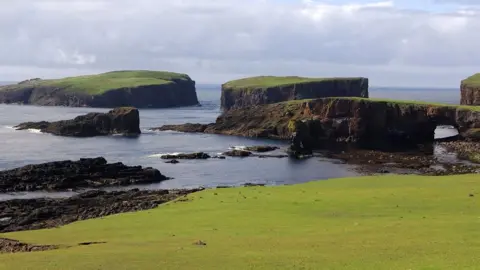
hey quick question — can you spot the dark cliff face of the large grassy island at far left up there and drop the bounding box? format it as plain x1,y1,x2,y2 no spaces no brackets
0,80,198,108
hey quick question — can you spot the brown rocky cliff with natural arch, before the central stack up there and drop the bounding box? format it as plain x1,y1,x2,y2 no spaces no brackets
158,98,480,151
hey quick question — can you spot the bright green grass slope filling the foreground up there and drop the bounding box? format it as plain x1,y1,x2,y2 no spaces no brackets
0,175,480,270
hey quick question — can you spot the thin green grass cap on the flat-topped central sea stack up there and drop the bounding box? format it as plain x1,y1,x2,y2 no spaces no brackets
223,76,361,89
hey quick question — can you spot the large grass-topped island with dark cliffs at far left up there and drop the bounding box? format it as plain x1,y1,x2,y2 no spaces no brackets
0,70,198,108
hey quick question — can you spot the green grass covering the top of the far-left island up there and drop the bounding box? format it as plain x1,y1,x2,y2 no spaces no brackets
0,70,190,95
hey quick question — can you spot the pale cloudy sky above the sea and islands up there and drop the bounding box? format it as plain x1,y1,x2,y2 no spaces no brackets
0,0,480,88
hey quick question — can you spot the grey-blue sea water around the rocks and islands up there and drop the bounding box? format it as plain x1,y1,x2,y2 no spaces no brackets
0,85,460,200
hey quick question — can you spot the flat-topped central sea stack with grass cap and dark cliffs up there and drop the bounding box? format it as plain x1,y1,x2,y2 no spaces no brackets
222,76,368,110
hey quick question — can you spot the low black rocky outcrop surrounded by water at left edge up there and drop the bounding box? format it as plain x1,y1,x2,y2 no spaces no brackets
0,157,168,192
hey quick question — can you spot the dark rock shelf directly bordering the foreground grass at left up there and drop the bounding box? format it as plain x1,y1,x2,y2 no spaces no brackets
0,189,202,232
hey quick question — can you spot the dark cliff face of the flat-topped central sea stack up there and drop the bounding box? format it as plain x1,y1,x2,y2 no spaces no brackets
221,78,368,110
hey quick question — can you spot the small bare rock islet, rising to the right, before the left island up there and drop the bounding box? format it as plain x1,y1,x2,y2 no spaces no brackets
14,107,141,137
